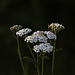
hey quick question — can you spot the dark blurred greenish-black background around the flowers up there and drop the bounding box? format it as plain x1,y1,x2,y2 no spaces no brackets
0,0,75,75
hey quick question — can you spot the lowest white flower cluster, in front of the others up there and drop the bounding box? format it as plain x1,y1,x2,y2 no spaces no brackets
33,43,53,53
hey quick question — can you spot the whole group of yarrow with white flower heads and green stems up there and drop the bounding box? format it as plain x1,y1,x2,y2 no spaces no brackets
10,23,65,75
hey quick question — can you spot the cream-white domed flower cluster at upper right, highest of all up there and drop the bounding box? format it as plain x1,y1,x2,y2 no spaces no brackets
48,23,65,32
